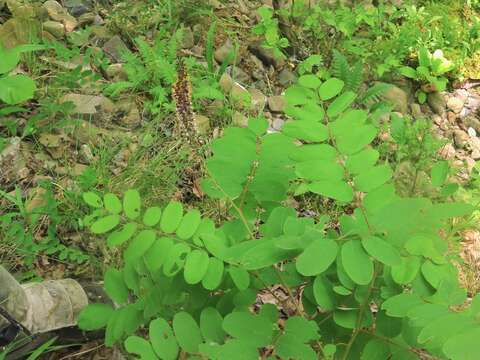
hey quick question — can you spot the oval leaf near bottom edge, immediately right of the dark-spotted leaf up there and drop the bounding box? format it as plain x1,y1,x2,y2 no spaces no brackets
173,311,203,353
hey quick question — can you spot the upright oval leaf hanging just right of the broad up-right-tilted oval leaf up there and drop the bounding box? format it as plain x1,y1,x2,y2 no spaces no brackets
341,240,373,285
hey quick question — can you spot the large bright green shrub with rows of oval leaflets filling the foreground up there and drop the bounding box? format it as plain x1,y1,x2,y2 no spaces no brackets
79,74,480,360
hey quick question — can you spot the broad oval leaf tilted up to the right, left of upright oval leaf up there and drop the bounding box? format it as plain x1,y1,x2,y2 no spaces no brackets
296,239,338,276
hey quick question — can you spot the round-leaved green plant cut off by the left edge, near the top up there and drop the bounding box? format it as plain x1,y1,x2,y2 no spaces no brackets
0,45,45,107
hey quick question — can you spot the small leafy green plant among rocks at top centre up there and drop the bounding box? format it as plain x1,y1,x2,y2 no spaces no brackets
252,6,289,58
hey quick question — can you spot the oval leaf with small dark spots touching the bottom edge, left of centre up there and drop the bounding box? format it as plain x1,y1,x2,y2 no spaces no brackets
149,318,178,360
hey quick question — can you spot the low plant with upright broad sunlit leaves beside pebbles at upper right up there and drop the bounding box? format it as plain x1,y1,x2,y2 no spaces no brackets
399,48,455,104
